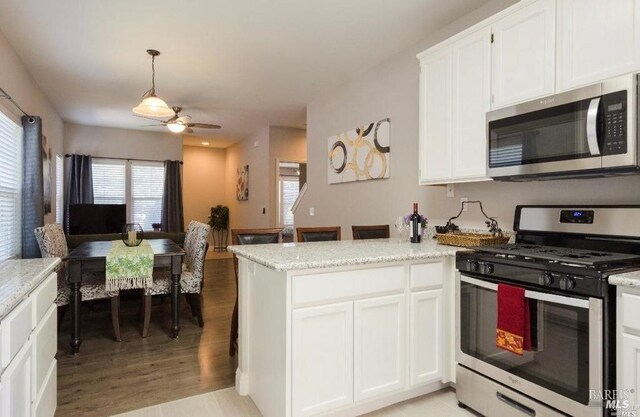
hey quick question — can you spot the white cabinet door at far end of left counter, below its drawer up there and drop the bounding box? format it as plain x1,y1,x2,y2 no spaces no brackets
31,305,58,398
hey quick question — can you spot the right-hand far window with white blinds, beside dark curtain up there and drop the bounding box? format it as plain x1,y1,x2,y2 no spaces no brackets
131,161,164,230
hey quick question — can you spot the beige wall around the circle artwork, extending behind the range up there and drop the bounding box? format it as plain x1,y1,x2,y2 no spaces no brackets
295,0,592,239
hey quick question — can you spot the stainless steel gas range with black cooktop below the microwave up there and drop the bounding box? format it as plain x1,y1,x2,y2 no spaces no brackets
456,206,640,417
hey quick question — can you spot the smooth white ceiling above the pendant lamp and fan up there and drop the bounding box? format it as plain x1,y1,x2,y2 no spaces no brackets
0,0,487,146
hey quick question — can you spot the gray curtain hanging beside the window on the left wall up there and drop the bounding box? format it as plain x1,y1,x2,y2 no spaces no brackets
22,116,44,259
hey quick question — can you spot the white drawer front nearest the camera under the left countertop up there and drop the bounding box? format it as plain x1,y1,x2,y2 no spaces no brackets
0,298,33,367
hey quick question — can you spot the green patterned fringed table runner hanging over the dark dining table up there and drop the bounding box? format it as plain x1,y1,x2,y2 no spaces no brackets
106,240,153,291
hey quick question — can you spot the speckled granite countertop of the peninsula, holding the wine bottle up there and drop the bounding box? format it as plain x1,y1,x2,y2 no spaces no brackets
227,238,463,271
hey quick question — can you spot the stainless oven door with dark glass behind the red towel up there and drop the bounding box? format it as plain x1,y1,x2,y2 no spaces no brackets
456,274,603,416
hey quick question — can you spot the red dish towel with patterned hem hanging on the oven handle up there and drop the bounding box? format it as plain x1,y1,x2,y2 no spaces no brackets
496,284,531,355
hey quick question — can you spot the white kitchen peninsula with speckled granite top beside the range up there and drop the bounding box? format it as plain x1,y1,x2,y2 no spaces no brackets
229,239,457,417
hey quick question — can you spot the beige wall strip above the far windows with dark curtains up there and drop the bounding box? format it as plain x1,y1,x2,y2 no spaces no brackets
64,123,182,161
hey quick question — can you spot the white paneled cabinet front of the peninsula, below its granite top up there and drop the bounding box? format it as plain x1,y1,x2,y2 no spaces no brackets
291,260,443,416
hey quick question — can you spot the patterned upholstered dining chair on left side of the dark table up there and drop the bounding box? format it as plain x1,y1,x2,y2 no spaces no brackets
34,223,122,342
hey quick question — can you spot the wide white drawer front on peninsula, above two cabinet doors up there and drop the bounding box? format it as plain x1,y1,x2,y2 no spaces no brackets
293,265,404,304
